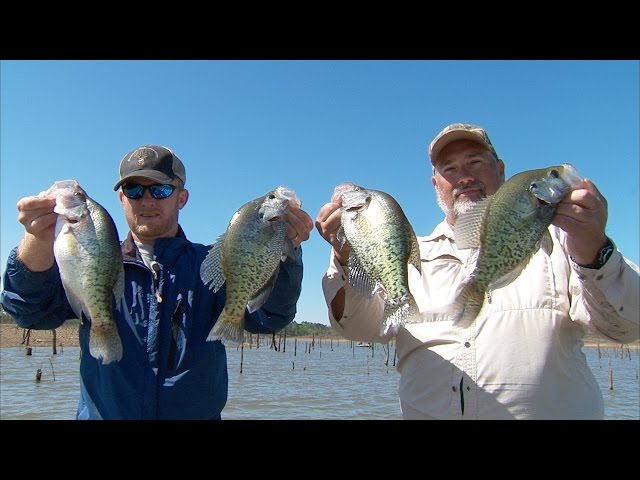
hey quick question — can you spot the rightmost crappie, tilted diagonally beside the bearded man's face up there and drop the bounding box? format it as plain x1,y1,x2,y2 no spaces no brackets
453,163,582,325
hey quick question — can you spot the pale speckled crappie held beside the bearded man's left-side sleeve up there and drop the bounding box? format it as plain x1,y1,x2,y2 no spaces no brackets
332,183,422,335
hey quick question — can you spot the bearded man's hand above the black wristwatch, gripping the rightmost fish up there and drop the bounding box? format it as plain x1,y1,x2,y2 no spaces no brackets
552,179,608,265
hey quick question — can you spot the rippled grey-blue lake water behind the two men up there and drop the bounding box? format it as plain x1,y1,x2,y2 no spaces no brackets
0,339,640,420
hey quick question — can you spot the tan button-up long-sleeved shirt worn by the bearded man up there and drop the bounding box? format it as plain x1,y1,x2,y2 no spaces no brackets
322,221,640,419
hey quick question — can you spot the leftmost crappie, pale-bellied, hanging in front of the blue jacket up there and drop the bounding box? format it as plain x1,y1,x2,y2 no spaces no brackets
41,180,124,364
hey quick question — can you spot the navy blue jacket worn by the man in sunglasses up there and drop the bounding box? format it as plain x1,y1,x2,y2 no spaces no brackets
2,228,303,419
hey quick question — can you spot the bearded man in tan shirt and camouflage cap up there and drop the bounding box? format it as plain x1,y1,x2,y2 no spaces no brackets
316,124,640,419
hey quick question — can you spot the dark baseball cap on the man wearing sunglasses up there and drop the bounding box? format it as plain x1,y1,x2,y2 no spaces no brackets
113,145,187,190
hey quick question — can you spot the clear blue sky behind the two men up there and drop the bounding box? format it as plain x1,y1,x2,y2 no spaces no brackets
0,60,640,324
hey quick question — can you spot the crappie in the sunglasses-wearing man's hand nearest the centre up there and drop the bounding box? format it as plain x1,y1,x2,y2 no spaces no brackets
200,186,301,346
